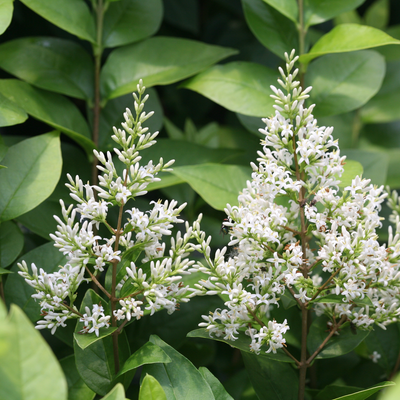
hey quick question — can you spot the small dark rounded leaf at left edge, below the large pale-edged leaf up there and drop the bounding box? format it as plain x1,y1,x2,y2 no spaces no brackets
0,221,24,268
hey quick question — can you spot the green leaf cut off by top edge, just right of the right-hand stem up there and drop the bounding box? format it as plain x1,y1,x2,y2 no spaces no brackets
304,0,365,26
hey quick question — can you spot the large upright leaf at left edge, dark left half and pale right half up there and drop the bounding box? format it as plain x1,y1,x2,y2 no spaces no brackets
0,132,62,221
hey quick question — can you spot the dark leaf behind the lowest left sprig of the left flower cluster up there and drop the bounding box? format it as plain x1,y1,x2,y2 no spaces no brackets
4,243,66,322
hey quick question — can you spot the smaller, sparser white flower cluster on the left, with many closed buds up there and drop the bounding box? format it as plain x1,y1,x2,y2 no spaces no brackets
19,81,206,336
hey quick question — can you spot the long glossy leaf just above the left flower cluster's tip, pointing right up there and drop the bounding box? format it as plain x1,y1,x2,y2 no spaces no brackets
101,36,237,100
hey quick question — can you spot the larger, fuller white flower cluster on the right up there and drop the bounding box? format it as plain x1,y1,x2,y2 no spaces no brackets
190,52,400,353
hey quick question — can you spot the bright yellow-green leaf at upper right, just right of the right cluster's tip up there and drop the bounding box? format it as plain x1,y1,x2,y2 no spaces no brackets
300,24,400,65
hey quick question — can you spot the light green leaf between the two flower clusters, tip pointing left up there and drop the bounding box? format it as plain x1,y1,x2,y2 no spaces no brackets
172,164,251,210
